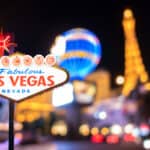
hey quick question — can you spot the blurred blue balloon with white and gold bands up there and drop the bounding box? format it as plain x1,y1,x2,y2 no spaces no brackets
52,28,101,81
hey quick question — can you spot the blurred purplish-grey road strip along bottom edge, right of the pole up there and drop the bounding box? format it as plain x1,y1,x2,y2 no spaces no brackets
15,142,144,150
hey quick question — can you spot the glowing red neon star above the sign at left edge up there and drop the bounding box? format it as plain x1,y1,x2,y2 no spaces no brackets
0,32,16,56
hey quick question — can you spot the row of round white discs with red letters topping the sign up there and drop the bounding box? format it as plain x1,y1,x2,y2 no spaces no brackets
0,54,56,67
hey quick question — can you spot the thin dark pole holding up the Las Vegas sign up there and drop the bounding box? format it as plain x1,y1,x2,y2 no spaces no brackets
9,101,15,150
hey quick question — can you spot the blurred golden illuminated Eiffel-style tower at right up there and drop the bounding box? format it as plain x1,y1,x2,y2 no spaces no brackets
122,9,148,96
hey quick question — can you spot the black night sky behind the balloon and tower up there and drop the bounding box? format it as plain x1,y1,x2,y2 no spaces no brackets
0,0,150,80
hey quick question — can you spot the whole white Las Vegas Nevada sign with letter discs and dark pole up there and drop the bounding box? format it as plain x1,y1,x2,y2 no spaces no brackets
0,54,68,150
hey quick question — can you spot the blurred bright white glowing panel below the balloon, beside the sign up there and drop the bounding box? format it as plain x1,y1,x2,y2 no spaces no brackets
52,83,74,107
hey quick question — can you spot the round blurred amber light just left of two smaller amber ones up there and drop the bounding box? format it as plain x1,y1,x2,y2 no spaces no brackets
79,124,90,136
